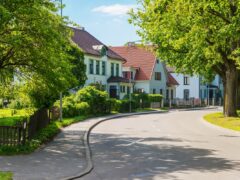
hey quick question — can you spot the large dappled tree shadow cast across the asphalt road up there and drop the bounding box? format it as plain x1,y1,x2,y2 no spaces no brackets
88,133,240,180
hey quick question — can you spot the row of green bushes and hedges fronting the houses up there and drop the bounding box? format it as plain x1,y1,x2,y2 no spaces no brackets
55,86,162,117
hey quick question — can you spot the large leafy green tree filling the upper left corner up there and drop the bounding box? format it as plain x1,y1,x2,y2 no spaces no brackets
0,0,86,107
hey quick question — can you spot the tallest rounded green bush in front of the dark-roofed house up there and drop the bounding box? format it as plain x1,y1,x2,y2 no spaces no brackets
75,86,108,114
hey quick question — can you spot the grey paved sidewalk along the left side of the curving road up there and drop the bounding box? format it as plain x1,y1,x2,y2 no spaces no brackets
0,111,165,180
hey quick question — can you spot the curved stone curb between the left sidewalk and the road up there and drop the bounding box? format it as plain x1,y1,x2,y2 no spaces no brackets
62,111,169,180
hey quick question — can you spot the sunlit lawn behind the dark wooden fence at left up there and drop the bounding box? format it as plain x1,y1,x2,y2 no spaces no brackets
0,109,33,126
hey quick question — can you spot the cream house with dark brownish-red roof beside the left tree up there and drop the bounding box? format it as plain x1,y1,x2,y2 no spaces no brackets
72,28,132,98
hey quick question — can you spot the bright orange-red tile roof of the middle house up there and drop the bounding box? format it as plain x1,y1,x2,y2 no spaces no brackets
110,46,156,80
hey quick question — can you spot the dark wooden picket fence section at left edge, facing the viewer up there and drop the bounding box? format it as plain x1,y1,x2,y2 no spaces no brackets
0,123,27,146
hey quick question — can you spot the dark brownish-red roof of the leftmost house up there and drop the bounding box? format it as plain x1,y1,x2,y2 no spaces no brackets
72,28,126,61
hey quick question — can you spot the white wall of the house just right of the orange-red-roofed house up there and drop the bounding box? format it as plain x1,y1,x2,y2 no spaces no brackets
172,73,200,99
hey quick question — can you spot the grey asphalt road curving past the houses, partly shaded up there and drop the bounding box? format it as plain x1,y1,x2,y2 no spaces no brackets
81,110,240,180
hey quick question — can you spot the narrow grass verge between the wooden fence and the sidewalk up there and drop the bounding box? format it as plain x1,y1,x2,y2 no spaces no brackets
0,116,89,156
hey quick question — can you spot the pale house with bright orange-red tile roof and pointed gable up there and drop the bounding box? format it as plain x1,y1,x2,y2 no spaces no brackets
110,43,178,99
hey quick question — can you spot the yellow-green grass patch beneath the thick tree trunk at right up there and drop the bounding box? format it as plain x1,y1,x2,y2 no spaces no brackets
204,113,240,131
